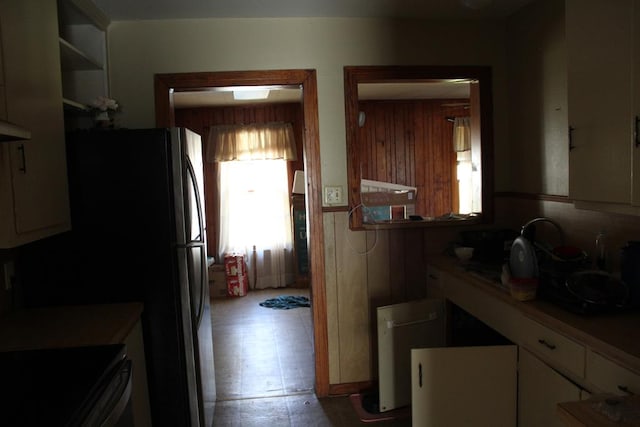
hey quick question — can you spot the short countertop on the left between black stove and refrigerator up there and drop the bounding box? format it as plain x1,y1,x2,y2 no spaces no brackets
0,303,143,351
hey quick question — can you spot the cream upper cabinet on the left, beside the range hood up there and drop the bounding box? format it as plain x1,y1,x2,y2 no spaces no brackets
0,0,70,248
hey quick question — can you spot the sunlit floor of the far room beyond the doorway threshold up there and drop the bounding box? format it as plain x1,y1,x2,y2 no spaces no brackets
211,288,315,401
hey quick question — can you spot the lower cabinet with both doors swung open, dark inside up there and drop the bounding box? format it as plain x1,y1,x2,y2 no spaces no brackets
378,298,517,427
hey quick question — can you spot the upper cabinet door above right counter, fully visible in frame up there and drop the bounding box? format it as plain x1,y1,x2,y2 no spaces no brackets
566,0,633,205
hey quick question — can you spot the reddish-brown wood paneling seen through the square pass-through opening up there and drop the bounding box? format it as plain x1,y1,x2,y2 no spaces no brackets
358,99,469,216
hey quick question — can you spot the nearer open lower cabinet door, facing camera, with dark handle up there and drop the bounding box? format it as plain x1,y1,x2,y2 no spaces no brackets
411,345,516,427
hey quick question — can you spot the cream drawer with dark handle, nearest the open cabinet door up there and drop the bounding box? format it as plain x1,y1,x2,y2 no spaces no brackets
520,317,585,377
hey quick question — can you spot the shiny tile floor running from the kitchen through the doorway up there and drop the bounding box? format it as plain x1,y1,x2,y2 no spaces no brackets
211,288,411,427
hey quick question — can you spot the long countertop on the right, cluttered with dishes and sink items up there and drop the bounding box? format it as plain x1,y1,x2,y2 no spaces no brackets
429,256,640,374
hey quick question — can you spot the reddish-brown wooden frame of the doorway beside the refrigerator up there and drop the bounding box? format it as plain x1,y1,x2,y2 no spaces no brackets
154,70,329,397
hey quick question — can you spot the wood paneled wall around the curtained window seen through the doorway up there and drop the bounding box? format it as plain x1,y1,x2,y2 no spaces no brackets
175,103,304,259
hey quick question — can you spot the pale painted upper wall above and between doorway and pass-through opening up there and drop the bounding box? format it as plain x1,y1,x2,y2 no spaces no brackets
109,18,508,194
